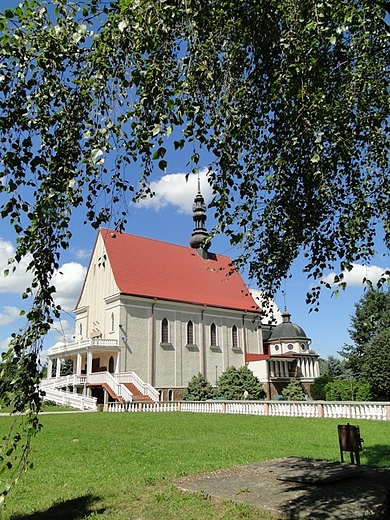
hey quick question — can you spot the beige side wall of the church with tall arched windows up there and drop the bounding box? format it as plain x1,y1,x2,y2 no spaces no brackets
116,296,261,388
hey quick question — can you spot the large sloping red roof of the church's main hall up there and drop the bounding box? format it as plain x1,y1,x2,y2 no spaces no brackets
100,229,259,312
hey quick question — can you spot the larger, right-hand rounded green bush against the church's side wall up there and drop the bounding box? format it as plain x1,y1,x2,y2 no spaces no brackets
217,366,266,399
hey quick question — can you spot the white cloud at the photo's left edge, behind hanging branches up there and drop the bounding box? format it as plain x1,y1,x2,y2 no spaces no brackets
0,238,32,293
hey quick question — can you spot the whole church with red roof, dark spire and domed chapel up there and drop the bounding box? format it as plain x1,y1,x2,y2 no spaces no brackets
47,183,318,403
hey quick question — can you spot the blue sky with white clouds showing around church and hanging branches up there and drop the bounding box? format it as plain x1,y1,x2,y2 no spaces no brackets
0,0,390,366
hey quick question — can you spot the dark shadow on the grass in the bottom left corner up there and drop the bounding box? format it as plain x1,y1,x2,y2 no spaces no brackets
11,495,104,520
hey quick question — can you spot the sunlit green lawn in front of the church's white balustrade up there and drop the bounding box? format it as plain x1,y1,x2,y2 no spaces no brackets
0,413,390,520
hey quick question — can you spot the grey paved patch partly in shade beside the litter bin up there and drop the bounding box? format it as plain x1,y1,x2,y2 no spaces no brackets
175,457,390,520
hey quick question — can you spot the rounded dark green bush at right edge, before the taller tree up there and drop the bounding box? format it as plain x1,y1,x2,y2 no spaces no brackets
362,328,390,401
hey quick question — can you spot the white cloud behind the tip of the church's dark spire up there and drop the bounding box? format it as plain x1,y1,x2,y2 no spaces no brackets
139,168,213,214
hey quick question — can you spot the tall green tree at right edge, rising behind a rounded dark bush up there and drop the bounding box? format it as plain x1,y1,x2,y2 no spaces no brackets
340,288,390,379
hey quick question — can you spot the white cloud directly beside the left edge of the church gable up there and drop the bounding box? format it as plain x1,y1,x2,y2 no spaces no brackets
52,262,86,312
